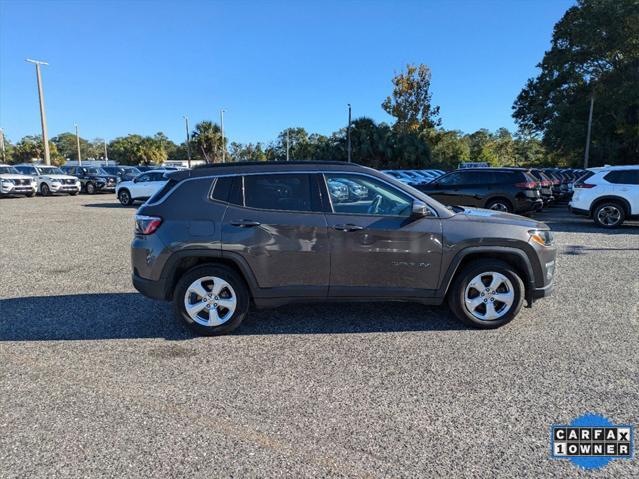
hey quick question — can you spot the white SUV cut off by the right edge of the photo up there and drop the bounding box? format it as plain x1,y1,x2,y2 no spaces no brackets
570,165,639,228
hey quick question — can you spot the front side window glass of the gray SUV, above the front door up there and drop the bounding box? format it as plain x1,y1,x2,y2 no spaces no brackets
324,173,413,217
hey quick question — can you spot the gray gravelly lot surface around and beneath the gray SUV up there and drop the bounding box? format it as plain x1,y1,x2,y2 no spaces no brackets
0,195,639,478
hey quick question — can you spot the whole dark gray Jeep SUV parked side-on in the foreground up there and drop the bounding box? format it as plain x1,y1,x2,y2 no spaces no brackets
131,162,556,335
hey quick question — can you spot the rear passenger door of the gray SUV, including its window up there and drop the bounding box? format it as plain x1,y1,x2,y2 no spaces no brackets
222,173,330,297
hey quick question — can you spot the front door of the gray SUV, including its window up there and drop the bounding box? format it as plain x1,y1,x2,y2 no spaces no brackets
325,173,442,298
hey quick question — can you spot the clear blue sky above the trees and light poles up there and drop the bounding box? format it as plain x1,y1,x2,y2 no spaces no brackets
0,0,574,143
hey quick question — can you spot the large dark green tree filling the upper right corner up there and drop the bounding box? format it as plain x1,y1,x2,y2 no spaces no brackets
513,0,639,165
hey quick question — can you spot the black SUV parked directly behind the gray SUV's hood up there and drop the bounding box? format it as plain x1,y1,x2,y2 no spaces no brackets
416,168,543,213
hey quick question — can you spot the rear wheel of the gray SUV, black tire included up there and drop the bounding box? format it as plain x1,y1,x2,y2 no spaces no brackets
173,265,250,336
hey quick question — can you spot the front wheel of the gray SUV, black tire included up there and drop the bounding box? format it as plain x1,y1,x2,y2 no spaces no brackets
448,259,525,329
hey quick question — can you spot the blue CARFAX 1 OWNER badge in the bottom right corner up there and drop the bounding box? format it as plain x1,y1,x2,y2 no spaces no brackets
550,414,634,469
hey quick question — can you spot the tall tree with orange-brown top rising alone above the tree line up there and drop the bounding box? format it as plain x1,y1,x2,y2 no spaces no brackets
382,64,441,133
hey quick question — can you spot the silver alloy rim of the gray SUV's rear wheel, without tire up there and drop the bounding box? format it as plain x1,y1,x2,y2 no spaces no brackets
184,276,237,326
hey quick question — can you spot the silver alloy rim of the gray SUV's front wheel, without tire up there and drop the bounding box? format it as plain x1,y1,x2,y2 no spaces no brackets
464,271,515,321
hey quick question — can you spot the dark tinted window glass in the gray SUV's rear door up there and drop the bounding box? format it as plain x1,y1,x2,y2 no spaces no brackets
244,174,316,211
